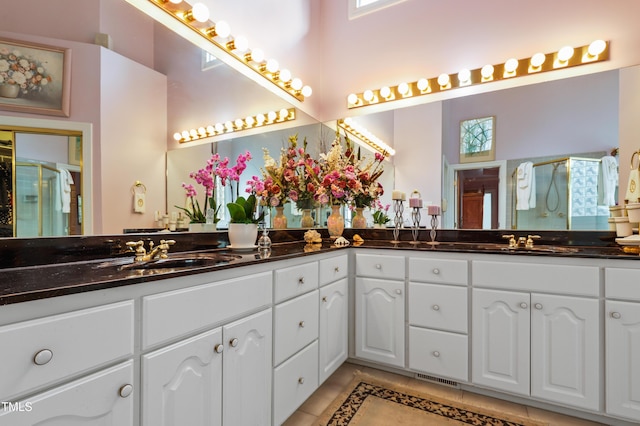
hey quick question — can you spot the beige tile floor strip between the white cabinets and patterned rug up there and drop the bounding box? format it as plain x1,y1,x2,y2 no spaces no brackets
283,363,601,426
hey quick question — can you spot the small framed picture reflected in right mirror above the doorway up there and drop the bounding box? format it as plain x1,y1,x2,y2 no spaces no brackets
460,117,496,163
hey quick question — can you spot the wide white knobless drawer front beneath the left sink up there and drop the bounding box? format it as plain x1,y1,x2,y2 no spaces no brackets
142,272,272,349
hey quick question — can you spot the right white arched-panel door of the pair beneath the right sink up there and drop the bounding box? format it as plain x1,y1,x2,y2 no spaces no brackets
531,294,600,410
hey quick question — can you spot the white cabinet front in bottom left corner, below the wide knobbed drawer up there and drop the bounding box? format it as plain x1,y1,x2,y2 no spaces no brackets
0,361,134,426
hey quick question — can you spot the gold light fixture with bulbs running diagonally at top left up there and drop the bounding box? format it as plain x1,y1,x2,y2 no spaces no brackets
127,0,312,102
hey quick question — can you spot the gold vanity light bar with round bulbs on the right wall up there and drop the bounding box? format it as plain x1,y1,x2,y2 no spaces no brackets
347,40,609,109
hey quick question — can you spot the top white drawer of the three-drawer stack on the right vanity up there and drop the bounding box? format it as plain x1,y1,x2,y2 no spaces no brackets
409,257,468,285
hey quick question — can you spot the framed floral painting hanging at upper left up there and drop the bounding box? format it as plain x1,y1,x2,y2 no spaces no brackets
0,39,71,117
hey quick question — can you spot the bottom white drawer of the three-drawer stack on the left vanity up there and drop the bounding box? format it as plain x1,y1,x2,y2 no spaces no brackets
273,341,318,425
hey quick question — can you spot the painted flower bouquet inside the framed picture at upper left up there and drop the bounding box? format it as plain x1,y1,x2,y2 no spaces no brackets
0,48,52,95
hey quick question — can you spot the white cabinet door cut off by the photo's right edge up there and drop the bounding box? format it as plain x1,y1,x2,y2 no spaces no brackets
605,301,640,422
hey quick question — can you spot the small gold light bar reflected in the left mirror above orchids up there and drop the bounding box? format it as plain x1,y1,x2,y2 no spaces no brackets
173,108,296,143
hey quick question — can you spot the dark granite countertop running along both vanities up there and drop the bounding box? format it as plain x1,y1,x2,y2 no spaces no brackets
0,230,640,305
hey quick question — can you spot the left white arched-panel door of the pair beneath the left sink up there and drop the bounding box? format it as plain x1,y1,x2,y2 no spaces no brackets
142,328,224,426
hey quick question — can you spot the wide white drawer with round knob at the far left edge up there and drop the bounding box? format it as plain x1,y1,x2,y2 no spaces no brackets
0,301,134,401
